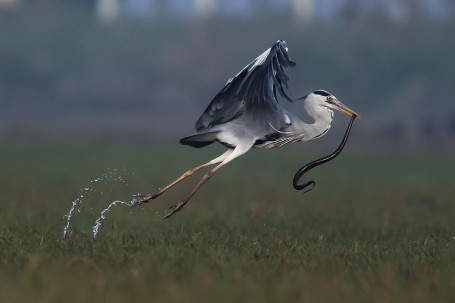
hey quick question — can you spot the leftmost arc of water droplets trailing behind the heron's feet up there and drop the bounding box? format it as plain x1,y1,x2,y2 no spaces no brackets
63,169,130,239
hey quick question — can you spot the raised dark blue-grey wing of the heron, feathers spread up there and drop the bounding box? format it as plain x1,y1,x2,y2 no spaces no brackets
196,40,295,131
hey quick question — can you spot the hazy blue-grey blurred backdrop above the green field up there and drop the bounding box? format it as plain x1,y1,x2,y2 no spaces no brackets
0,0,455,148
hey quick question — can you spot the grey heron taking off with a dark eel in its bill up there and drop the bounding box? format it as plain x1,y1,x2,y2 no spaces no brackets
137,40,360,218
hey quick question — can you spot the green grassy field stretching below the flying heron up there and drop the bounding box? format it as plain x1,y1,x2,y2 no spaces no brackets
0,140,455,302
